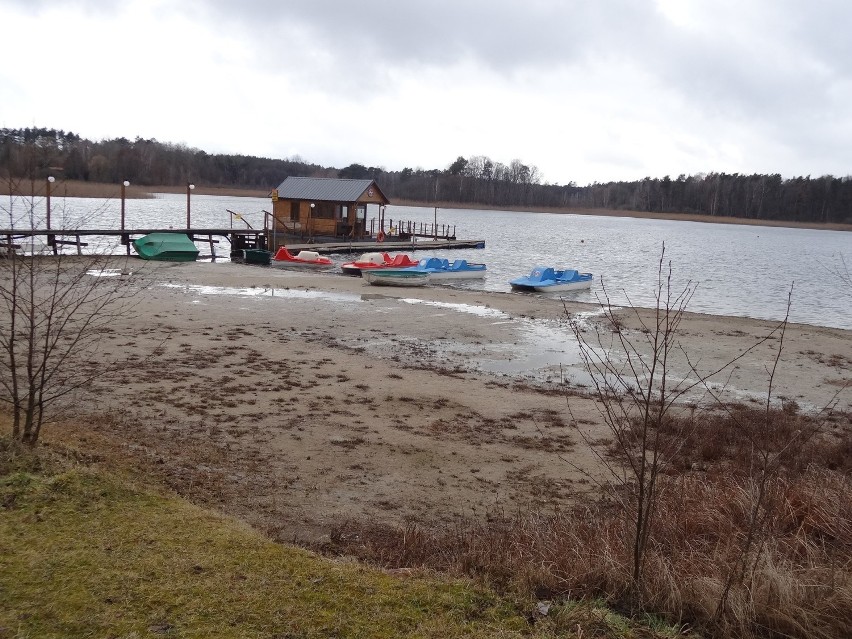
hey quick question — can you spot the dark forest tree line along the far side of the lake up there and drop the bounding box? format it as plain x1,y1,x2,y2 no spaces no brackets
0,128,852,223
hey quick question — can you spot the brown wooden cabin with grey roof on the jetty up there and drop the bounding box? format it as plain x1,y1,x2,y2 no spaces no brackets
270,177,389,250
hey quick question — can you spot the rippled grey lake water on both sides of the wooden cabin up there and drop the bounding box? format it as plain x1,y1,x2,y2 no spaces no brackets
8,194,852,329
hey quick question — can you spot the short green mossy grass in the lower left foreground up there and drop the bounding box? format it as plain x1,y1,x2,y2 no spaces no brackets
0,470,530,638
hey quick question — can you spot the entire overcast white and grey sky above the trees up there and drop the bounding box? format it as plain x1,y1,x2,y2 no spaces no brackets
0,0,852,185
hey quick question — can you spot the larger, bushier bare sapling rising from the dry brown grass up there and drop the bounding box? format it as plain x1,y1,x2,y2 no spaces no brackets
570,246,769,609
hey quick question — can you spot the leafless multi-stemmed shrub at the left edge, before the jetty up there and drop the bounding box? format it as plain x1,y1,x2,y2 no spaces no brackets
0,185,144,445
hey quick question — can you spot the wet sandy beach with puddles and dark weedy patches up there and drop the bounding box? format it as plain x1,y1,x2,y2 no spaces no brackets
54,259,852,544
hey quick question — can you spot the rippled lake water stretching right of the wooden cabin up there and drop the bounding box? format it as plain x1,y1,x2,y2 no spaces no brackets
386,207,852,328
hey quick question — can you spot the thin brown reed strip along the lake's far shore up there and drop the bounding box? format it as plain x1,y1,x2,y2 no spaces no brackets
0,180,852,231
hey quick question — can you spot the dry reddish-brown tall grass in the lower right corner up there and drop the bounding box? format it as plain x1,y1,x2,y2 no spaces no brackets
326,408,852,638
